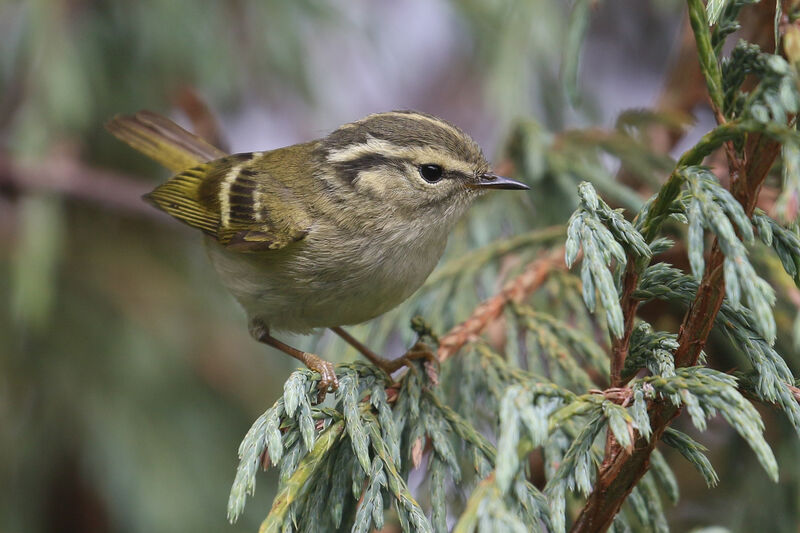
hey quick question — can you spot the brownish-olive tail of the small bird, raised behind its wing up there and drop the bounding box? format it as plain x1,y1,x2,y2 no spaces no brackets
106,111,228,172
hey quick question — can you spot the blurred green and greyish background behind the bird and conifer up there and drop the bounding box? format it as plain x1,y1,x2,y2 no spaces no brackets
0,0,800,533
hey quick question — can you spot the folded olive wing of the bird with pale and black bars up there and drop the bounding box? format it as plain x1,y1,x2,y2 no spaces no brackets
145,149,311,252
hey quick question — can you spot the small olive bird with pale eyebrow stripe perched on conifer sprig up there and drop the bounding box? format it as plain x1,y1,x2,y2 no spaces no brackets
107,111,528,395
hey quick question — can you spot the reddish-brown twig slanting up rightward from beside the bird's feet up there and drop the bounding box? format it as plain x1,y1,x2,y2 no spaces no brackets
436,247,566,361
